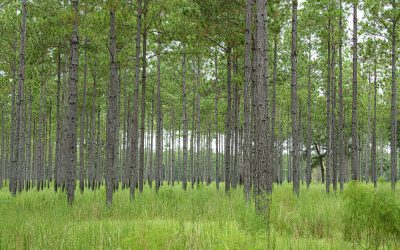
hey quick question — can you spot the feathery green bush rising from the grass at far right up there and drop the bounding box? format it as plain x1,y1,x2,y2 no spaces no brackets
343,182,400,248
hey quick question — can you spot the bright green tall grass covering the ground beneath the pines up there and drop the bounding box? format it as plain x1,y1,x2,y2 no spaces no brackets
0,181,400,249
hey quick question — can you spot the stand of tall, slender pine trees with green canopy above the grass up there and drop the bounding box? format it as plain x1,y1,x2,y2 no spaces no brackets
0,0,400,209
